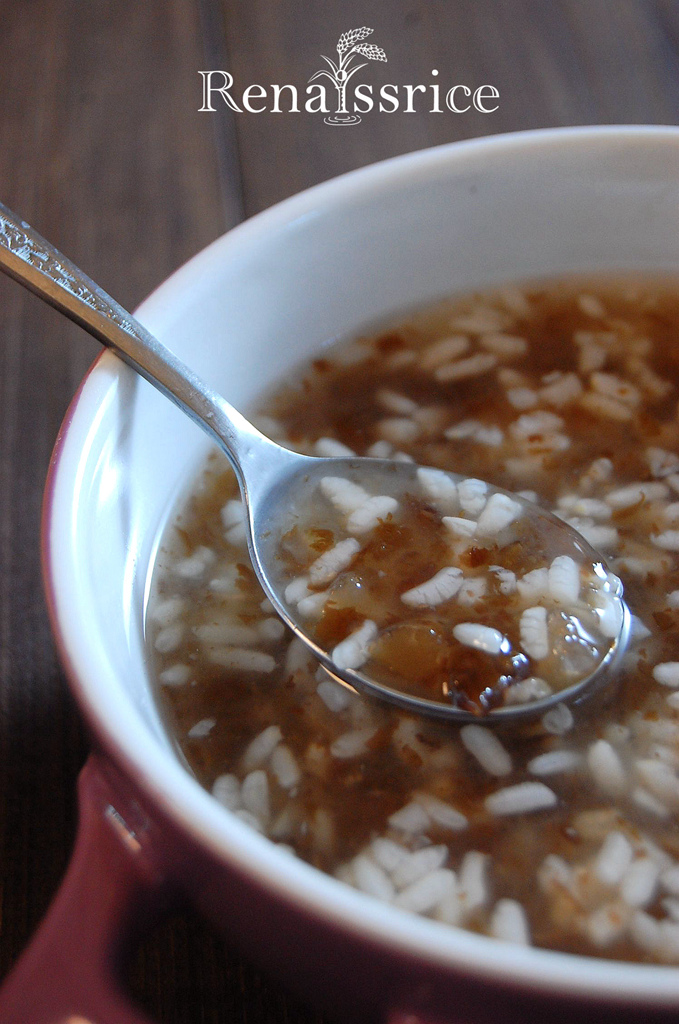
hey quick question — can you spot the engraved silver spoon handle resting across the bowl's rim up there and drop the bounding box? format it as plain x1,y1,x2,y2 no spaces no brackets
0,203,285,486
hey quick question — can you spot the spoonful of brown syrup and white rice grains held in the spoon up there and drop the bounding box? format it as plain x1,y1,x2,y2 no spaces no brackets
279,463,623,716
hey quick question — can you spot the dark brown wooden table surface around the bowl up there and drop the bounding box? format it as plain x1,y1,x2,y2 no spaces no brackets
0,0,679,1024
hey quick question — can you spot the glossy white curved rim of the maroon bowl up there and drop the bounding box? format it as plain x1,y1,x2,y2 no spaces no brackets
42,125,679,1008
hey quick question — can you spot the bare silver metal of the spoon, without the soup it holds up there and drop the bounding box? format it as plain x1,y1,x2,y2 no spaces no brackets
0,204,630,722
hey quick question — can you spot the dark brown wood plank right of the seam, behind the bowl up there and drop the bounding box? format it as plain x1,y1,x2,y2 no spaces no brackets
222,0,679,214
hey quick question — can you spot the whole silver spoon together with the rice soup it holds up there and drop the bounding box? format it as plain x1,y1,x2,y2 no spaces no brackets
0,205,630,721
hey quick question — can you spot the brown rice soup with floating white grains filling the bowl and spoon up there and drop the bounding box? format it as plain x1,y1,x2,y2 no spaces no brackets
146,278,679,964
